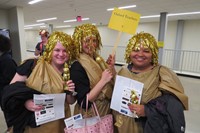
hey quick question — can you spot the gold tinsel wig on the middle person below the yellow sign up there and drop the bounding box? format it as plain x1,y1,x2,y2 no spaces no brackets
72,24,102,55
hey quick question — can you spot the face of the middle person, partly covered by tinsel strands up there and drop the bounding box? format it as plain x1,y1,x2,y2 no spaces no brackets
82,36,98,56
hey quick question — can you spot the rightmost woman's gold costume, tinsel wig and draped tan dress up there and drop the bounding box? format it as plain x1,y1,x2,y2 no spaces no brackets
113,32,188,133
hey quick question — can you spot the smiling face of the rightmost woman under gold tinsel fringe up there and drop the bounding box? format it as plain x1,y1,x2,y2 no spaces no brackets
130,45,153,69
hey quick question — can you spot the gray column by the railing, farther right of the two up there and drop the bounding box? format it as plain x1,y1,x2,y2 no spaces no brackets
173,20,185,70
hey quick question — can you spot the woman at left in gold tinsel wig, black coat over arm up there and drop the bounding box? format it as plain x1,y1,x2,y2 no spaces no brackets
3,32,75,133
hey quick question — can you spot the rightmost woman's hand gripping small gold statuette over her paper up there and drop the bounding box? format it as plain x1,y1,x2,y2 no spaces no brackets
128,104,145,117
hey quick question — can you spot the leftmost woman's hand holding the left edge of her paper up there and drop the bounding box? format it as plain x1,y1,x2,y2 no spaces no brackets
25,99,44,112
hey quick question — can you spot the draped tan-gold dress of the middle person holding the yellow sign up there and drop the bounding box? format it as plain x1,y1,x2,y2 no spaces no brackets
74,53,113,116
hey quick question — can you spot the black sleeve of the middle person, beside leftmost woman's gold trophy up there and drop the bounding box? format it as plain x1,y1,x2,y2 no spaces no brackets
70,61,91,109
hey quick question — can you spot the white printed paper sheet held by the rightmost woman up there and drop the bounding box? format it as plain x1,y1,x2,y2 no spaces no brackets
110,75,144,117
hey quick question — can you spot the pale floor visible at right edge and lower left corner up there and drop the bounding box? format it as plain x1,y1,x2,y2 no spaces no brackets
0,76,200,133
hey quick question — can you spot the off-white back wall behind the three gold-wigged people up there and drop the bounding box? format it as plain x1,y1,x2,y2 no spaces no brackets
26,20,200,62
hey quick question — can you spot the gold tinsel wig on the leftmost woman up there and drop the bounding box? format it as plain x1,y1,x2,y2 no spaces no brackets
41,31,75,63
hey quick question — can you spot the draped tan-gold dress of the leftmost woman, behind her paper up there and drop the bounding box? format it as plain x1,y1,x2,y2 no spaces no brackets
25,60,71,133
